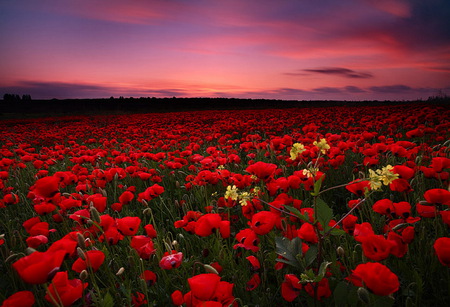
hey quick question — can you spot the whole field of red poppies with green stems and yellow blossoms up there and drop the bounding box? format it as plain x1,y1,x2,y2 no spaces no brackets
0,105,450,306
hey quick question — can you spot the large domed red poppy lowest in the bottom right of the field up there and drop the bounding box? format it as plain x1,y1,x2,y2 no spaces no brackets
349,262,400,296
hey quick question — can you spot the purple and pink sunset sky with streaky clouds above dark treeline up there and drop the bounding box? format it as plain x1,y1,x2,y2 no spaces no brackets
0,0,450,100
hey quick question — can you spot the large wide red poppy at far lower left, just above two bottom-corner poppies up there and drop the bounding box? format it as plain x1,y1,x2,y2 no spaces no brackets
12,250,66,284
